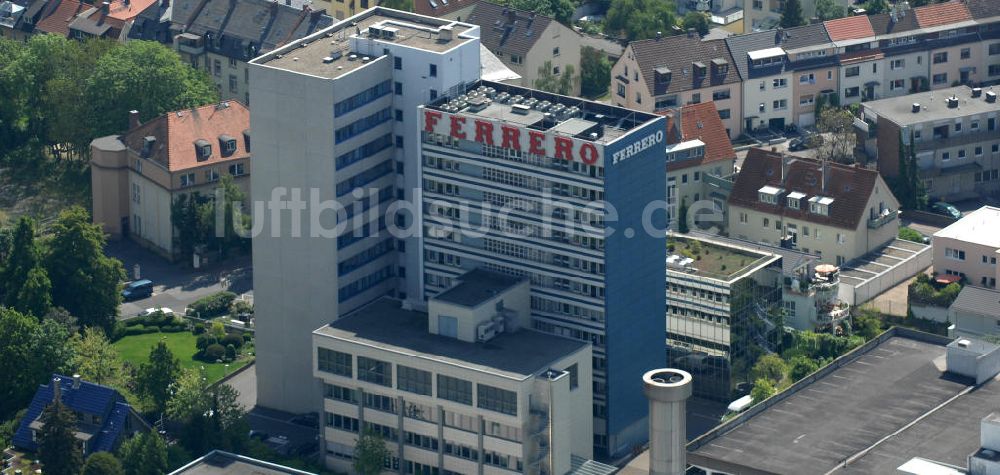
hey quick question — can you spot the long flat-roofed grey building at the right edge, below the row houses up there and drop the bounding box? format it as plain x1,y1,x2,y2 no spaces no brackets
858,86,1000,200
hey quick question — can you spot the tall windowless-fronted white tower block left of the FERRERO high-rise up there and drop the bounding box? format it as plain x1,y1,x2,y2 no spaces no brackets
250,8,480,412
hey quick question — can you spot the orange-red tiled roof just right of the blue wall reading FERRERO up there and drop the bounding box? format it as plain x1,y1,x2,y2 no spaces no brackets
664,102,736,174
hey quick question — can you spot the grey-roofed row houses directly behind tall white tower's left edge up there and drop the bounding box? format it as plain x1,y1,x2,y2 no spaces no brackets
172,0,333,104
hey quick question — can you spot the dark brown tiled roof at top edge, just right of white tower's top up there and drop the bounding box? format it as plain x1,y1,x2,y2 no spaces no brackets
464,2,553,59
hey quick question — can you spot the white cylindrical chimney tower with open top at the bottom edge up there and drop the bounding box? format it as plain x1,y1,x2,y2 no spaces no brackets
642,368,691,475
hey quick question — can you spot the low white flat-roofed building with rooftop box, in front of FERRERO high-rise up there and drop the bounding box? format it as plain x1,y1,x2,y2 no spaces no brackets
312,270,592,475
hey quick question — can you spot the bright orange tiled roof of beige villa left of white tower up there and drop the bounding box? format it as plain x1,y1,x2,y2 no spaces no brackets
125,101,250,172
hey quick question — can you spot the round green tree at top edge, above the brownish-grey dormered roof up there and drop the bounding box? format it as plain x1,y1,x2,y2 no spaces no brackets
604,0,677,41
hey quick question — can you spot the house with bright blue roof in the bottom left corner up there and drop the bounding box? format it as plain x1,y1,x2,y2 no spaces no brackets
12,374,150,456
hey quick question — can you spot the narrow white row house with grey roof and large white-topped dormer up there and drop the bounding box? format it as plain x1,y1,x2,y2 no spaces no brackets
726,29,795,133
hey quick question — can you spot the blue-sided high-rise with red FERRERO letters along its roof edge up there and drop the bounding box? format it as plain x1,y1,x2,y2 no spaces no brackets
420,81,666,456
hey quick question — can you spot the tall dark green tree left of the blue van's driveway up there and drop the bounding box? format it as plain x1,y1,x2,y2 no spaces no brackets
45,206,125,333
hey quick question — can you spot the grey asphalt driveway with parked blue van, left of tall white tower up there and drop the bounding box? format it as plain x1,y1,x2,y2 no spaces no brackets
107,239,253,318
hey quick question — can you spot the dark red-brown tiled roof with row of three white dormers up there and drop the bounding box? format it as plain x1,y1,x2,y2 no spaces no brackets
729,148,884,230
